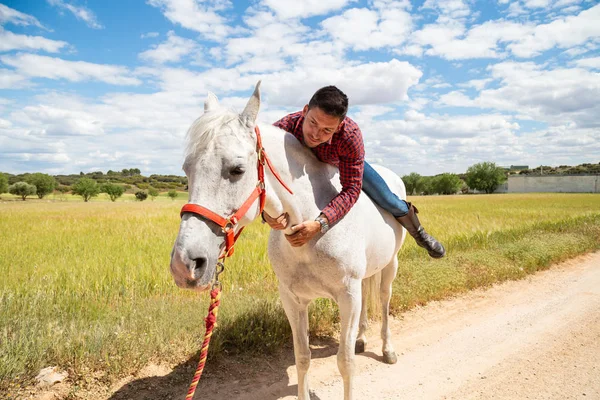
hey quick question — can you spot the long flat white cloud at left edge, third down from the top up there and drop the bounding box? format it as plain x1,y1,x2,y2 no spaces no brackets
0,53,141,85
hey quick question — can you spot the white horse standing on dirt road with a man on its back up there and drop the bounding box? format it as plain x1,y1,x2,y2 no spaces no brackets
171,82,406,400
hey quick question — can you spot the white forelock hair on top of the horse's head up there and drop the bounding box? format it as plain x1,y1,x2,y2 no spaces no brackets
185,108,248,159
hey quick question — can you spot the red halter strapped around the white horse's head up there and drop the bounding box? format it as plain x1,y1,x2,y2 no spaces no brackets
180,126,294,258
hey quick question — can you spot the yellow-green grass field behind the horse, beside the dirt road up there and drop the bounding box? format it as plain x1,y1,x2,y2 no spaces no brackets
0,194,600,393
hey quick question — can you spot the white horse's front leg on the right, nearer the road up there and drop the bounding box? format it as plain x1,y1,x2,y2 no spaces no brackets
337,279,362,400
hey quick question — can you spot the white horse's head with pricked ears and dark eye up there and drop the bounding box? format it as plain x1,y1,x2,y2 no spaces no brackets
171,82,260,290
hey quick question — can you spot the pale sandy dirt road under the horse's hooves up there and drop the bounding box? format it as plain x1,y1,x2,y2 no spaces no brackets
36,253,600,400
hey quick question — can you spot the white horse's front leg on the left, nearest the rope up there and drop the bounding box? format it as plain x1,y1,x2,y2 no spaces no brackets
279,284,310,400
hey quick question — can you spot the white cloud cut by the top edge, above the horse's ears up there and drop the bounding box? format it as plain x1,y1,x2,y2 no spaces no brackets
148,0,239,41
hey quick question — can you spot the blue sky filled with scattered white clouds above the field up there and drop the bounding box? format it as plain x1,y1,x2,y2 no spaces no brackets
0,0,600,176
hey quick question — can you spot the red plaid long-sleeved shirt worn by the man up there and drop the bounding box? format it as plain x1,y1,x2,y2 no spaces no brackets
273,111,365,225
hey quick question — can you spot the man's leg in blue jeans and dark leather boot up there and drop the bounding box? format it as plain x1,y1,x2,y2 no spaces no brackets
362,162,446,258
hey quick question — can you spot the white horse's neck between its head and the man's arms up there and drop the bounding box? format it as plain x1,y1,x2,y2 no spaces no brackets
255,125,324,233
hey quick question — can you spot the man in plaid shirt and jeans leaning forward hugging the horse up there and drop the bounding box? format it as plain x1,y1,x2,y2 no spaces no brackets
263,86,446,258
